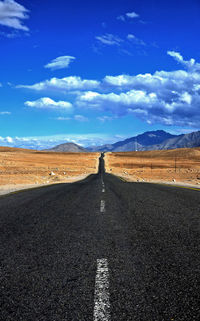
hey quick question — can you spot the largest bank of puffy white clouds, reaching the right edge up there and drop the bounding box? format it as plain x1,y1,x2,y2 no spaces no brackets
77,52,200,128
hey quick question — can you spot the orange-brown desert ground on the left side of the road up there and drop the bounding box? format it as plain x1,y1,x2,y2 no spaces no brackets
0,147,100,194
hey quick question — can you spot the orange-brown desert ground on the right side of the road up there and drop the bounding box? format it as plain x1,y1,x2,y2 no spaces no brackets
105,148,200,185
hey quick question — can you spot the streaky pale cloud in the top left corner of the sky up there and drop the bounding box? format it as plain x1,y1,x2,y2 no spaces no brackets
0,0,29,31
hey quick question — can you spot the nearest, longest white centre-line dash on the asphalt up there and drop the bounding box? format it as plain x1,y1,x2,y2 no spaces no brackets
93,259,110,321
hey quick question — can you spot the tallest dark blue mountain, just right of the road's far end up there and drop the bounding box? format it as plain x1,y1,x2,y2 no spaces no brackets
88,130,177,152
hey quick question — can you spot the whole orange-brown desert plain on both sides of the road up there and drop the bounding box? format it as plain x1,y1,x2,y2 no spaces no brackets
0,147,200,194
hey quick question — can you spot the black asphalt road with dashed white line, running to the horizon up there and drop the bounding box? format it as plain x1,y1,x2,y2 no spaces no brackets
0,154,200,321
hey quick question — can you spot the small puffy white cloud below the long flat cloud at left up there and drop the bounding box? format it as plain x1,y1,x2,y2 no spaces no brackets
24,97,72,110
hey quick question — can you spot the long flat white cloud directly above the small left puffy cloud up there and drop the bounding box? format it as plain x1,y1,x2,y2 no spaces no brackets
17,76,100,92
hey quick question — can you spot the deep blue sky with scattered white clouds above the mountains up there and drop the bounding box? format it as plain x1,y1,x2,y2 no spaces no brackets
0,0,200,148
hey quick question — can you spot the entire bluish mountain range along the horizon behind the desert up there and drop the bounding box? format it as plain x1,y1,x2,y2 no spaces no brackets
44,130,200,153
